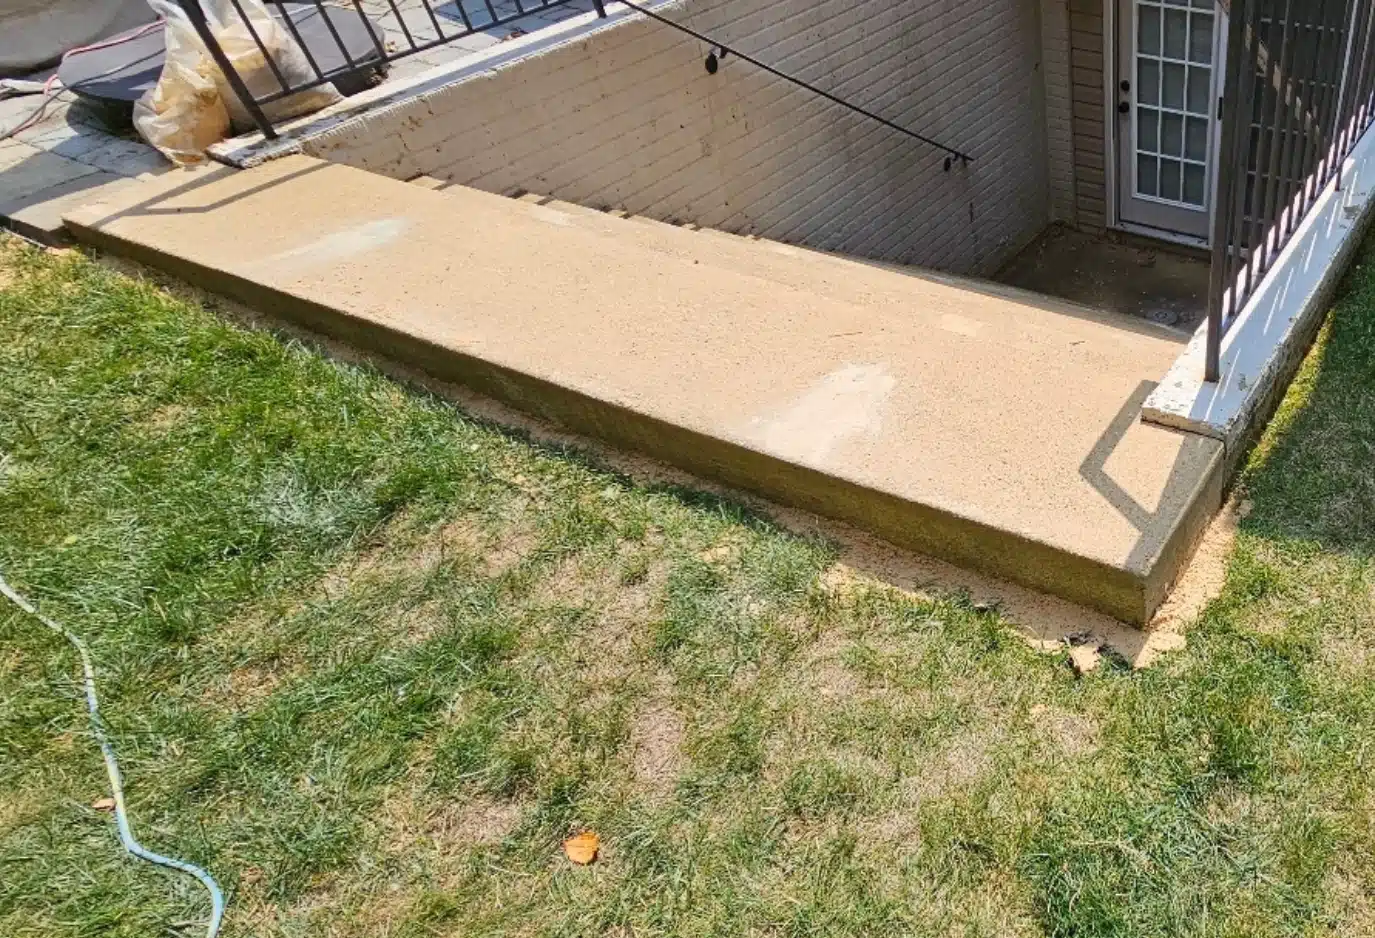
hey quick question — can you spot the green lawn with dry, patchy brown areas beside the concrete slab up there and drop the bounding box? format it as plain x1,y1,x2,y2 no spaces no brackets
0,232,1375,938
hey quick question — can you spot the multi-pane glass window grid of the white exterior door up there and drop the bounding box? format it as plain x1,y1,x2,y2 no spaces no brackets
1133,0,1214,210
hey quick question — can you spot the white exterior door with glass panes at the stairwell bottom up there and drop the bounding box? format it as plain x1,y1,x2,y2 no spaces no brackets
1114,0,1224,239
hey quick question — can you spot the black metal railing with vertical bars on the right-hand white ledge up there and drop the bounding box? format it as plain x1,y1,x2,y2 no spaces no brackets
1205,0,1375,381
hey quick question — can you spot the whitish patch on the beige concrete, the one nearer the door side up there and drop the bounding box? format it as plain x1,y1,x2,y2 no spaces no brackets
744,364,898,468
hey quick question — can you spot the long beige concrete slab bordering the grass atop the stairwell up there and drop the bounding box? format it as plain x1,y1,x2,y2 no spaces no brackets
67,157,1222,623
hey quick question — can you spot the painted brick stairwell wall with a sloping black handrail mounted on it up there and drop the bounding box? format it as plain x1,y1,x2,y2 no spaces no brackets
308,0,1051,272
